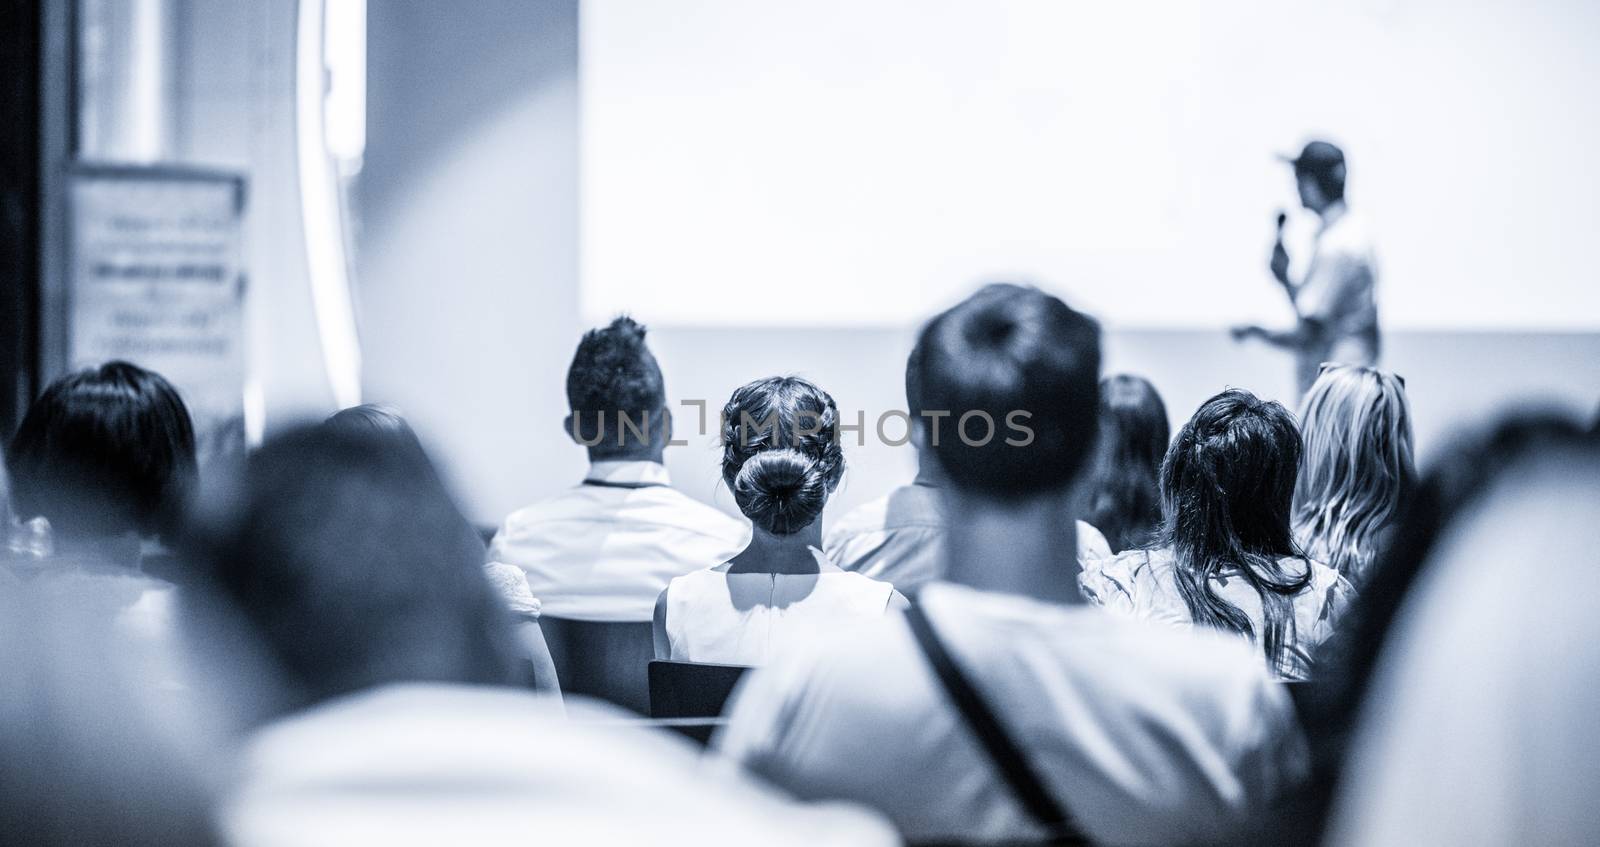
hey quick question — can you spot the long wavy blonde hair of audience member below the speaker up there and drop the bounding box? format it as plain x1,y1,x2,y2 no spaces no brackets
1293,365,1416,583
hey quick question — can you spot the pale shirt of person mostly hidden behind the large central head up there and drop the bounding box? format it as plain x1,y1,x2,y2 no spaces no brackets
822,482,1110,594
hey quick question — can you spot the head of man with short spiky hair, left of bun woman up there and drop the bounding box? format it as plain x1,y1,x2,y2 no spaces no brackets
565,317,672,461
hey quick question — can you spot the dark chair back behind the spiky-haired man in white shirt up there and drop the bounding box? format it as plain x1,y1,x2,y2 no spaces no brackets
539,615,656,716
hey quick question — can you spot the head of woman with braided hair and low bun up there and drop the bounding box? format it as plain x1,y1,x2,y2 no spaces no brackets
722,376,845,535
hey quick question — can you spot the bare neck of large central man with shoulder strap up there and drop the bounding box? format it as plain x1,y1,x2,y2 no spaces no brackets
944,487,1083,605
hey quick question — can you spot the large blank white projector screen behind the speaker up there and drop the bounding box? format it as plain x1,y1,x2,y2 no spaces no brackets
581,0,1600,330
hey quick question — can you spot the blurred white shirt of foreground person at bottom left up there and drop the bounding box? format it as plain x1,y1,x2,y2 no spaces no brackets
221,684,893,847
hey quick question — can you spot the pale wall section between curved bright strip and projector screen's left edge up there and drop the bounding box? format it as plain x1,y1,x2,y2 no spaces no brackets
355,0,584,522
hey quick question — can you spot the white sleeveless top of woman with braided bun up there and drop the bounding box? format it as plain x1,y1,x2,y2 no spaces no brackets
667,567,894,664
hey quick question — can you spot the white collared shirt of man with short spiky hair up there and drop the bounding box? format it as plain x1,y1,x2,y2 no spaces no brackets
488,461,750,621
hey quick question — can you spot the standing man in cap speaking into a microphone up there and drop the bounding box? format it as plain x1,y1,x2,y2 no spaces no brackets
1234,141,1378,392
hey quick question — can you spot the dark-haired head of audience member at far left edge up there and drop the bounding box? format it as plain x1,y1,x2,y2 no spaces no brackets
6,362,195,538
